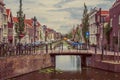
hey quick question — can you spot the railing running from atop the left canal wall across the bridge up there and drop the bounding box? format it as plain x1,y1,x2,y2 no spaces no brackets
0,42,94,57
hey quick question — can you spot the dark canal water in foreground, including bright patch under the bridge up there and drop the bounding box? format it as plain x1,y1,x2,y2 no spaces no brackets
11,56,120,80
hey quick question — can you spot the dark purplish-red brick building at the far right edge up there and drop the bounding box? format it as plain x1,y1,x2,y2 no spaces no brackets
110,0,120,49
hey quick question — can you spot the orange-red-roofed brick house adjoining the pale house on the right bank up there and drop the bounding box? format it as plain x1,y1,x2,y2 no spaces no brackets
96,9,109,49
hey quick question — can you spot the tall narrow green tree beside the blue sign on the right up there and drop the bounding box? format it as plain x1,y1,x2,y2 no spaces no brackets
82,3,89,42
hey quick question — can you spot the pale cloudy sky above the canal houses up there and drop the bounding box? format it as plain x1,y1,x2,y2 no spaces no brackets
4,0,115,33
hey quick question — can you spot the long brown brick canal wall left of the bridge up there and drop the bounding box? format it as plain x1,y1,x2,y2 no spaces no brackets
0,54,52,80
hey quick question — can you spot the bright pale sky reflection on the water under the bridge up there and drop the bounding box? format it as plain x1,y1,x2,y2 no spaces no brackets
55,56,81,71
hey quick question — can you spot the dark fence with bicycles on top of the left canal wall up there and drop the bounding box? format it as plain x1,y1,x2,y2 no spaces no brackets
0,43,45,57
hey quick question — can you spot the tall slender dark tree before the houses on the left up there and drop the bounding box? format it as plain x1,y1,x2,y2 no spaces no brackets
15,0,25,43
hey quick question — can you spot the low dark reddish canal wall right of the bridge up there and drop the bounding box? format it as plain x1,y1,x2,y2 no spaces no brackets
87,54,120,72
